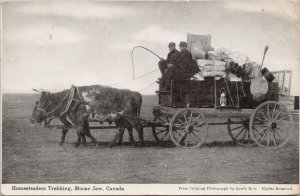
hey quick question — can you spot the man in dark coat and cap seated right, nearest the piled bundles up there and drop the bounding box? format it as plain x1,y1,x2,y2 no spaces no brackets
164,42,199,89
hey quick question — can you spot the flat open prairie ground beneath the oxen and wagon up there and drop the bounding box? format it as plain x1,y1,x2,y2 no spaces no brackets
2,94,299,184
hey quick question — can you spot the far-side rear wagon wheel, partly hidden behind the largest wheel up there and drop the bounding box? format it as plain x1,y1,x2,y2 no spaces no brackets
227,117,255,146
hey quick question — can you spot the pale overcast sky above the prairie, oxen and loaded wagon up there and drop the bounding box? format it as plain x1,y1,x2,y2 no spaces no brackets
2,1,300,94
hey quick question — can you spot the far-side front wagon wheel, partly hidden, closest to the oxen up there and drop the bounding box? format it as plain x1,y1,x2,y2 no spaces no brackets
152,117,170,144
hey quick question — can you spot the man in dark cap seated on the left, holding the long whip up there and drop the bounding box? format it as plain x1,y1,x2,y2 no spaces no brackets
158,42,180,76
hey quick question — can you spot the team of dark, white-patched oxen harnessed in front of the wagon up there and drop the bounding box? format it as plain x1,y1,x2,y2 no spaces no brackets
30,85,143,146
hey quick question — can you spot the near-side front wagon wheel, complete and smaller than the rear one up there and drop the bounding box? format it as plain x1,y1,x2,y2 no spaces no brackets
169,109,208,148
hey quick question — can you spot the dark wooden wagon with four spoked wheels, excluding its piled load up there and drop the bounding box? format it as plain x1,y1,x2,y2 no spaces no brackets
150,77,294,148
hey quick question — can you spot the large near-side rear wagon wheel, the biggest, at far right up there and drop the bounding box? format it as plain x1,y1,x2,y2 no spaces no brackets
250,101,294,148
